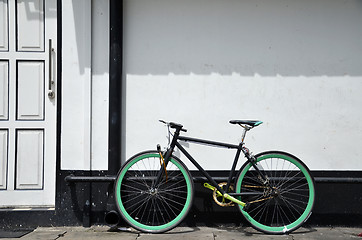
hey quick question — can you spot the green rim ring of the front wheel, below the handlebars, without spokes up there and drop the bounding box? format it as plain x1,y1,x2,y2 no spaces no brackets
116,153,192,231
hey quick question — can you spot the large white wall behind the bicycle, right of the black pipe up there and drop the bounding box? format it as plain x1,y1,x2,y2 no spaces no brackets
122,0,362,170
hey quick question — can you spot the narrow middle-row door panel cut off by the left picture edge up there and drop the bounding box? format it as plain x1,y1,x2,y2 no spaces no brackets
0,61,9,120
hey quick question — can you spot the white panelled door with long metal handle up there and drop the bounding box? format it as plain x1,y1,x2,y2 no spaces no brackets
0,0,57,207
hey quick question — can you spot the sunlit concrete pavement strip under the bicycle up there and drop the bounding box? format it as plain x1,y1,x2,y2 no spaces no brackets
7,226,362,240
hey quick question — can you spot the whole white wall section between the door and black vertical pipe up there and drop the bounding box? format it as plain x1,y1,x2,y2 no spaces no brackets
61,0,109,170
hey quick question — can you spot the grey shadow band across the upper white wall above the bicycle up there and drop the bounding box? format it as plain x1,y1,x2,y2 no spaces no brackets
124,0,362,76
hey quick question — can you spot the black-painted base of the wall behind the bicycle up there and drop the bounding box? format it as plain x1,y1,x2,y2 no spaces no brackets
0,171,362,228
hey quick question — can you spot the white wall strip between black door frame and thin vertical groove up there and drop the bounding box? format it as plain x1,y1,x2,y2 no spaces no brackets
61,0,92,170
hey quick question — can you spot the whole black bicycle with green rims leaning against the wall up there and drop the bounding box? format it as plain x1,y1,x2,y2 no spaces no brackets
115,120,315,234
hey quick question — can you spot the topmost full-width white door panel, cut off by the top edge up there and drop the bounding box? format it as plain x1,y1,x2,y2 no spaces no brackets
16,0,44,51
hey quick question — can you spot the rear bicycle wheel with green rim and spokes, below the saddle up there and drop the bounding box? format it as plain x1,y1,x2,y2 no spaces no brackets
236,151,315,234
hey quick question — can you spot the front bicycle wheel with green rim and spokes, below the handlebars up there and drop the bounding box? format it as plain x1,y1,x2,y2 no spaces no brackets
115,151,194,233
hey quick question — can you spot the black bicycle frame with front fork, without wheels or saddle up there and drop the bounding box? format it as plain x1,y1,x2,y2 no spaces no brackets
155,129,266,195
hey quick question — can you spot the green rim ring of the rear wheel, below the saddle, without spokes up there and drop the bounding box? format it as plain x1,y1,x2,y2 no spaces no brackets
236,153,314,233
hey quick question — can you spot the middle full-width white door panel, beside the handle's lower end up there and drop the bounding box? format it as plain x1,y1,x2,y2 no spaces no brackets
17,61,44,120
